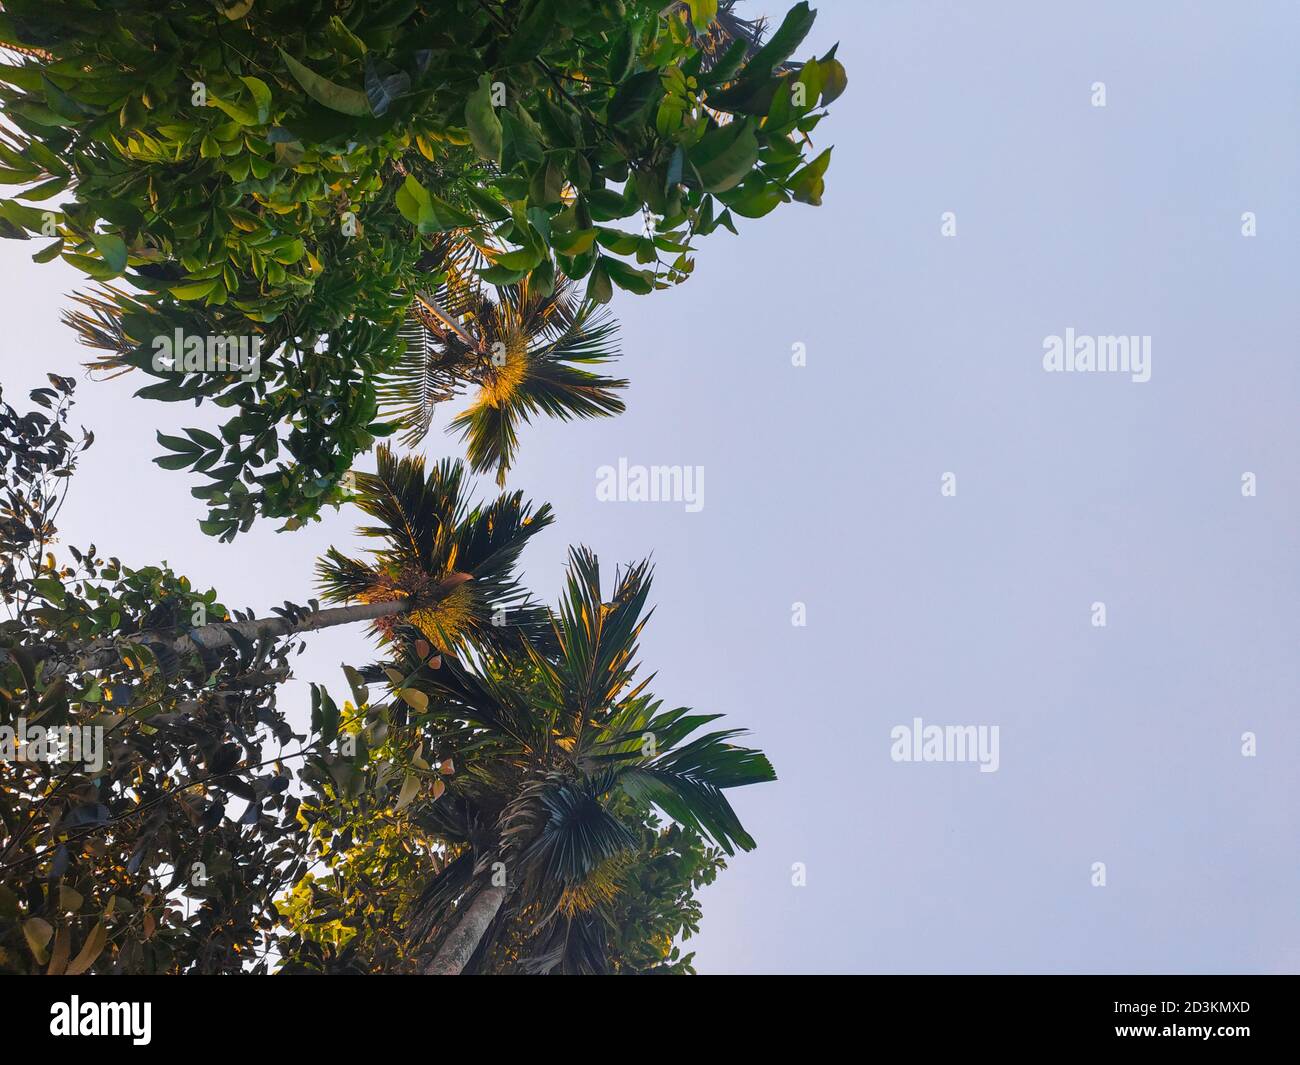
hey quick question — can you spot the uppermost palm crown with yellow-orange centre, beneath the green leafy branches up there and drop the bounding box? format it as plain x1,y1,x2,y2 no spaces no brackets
377,238,628,484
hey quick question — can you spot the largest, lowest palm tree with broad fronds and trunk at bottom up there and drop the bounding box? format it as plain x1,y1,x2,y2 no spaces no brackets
398,549,775,975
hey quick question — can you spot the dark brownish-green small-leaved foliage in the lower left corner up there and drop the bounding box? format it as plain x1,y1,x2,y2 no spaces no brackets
0,377,306,974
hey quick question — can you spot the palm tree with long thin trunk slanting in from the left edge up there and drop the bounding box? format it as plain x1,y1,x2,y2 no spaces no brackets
10,446,553,679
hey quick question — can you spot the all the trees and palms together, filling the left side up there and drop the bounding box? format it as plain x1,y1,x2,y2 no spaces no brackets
0,0,846,974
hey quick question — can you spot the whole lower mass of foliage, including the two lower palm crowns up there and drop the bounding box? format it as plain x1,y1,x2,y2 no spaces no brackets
0,377,772,974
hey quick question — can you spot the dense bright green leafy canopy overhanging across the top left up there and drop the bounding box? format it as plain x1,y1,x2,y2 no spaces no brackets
0,0,845,538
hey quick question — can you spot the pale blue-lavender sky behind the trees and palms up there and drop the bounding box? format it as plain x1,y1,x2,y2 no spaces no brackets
0,0,1300,973
